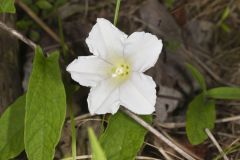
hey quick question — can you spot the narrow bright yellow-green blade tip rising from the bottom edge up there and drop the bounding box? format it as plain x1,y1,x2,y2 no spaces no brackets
88,128,107,160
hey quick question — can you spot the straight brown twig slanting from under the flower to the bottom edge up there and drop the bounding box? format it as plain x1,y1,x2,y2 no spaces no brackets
121,108,195,160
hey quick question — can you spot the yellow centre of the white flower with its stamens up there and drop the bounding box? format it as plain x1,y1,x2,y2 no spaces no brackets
112,63,131,79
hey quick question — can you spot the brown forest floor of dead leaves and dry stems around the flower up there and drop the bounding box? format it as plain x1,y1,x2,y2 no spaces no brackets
11,0,240,160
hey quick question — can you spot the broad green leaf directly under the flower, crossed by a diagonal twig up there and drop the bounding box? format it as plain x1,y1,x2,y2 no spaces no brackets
100,111,152,160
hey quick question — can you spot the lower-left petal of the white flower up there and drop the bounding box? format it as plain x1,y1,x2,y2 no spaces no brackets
87,78,120,114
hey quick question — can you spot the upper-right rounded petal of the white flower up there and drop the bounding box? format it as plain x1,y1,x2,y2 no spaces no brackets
124,32,163,72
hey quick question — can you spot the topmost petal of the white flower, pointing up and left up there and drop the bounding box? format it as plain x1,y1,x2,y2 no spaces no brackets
86,18,127,62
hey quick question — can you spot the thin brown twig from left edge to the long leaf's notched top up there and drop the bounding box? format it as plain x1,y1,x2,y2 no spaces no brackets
0,21,37,50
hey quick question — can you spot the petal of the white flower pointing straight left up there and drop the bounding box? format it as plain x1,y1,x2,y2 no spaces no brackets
67,56,112,86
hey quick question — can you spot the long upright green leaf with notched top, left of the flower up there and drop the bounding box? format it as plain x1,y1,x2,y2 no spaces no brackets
24,47,66,160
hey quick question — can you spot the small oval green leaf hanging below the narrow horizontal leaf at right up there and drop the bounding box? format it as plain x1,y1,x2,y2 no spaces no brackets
186,94,216,145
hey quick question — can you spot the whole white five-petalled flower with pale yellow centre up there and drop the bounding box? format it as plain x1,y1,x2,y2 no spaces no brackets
67,18,162,114
